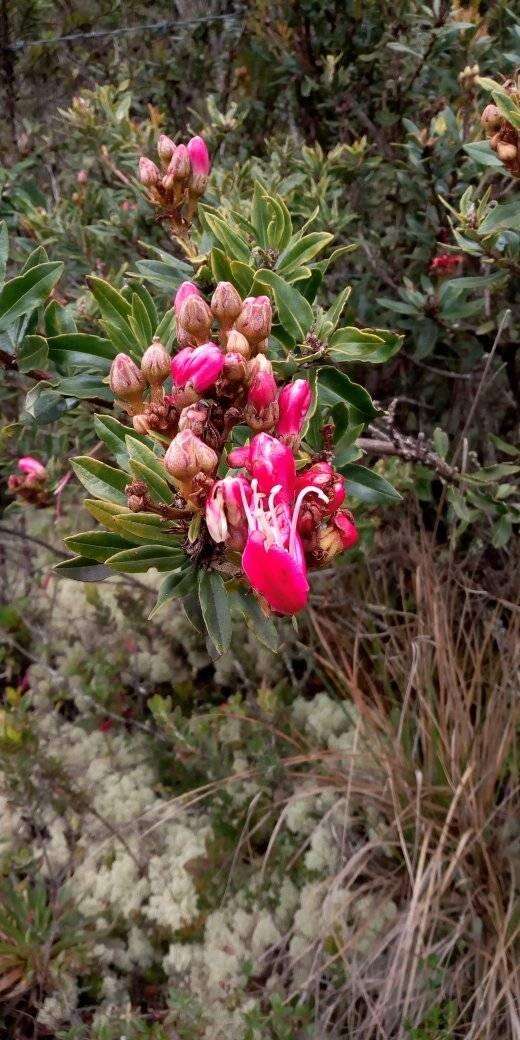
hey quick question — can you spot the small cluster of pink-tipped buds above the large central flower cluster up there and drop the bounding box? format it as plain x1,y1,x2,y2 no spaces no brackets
139,134,211,234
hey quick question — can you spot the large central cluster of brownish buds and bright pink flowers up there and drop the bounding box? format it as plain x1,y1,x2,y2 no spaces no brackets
110,282,358,614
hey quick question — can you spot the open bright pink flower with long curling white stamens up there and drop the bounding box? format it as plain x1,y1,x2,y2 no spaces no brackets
238,476,326,614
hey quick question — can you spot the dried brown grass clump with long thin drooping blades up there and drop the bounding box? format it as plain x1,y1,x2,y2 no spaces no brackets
295,528,520,1040
